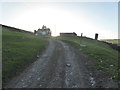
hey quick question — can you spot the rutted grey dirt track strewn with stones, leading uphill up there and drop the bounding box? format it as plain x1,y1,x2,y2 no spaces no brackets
6,40,117,88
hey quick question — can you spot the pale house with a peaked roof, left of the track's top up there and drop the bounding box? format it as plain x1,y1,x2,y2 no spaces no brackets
34,25,51,36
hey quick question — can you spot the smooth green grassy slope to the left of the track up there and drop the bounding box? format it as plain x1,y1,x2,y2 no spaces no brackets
2,30,48,83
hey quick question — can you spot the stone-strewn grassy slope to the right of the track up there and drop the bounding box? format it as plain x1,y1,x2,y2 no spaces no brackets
57,37,120,79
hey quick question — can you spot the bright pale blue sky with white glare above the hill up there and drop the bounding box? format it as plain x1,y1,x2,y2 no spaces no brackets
0,2,118,39
